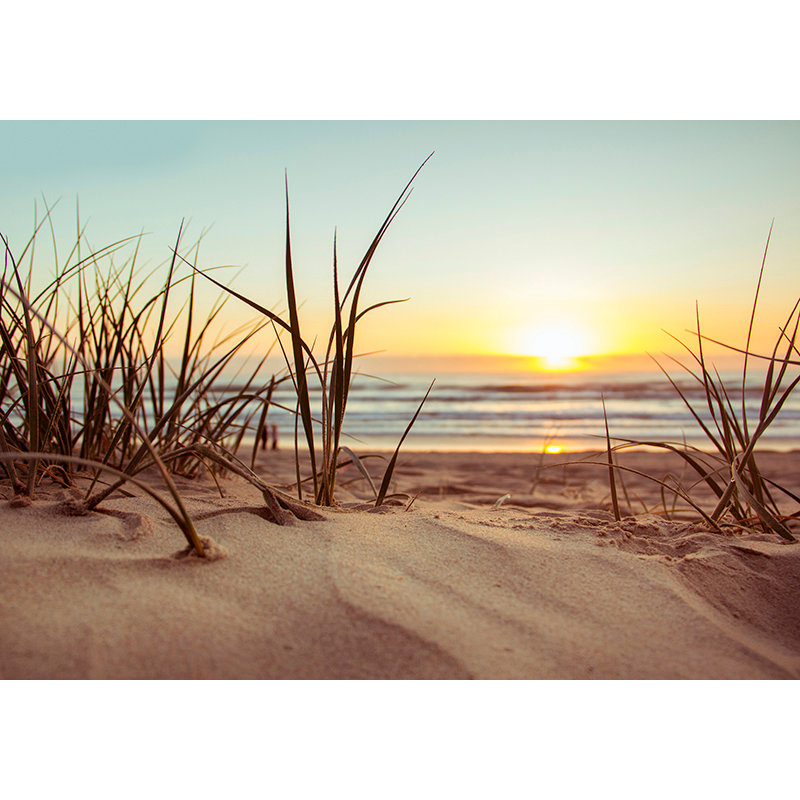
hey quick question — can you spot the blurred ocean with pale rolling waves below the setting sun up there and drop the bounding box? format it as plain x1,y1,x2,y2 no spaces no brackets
252,372,800,453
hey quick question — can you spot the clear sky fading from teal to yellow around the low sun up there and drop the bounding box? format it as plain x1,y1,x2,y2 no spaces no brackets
0,120,800,371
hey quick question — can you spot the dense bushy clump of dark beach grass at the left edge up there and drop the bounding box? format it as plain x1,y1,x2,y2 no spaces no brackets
0,212,274,494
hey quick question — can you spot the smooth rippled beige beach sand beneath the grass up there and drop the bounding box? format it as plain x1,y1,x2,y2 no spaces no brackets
0,451,800,680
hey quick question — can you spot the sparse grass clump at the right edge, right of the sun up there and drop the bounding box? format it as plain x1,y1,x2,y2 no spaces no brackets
606,222,800,542
